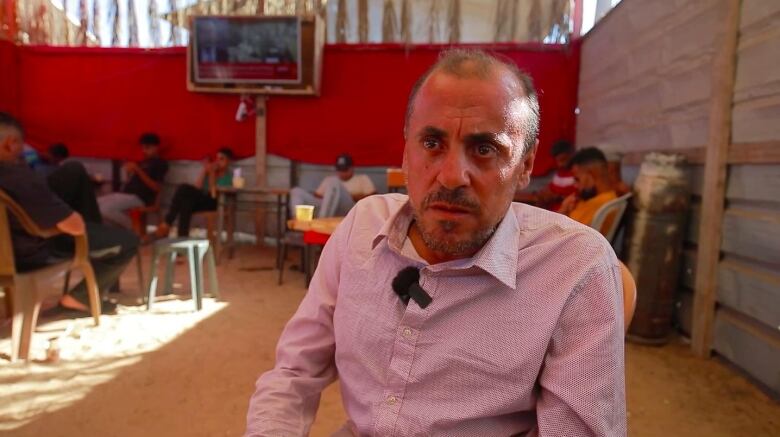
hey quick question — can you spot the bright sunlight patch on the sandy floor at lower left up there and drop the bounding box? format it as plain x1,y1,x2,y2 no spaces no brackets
0,298,227,431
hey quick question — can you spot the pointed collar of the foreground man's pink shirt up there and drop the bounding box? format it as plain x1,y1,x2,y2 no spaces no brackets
371,200,520,289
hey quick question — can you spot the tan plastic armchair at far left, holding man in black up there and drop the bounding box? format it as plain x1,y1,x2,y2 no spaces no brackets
0,190,100,361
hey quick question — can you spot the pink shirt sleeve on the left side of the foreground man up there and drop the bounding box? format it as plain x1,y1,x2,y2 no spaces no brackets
245,213,351,437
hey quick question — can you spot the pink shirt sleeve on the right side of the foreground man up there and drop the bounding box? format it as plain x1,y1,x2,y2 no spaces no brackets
532,254,626,437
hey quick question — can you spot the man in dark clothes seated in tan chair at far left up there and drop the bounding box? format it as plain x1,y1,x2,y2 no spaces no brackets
0,113,138,312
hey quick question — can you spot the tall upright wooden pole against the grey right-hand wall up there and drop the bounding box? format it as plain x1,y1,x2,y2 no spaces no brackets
691,0,740,357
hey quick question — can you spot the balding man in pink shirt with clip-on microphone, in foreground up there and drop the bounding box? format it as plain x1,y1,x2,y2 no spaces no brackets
246,50,626,436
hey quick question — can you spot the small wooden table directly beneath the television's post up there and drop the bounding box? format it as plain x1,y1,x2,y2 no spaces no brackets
214,187,290,265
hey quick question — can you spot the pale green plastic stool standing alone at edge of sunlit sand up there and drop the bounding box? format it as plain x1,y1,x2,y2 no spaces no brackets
146,238,219,311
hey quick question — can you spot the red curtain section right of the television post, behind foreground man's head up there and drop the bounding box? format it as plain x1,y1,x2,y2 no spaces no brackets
268,44,579,174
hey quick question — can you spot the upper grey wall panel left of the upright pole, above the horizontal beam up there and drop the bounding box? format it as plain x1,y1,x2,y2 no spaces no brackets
577,0,718,153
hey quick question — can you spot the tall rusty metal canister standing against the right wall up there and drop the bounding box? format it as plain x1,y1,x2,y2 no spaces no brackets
624,153,690,344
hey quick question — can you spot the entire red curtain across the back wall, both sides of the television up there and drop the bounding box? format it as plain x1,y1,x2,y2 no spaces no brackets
10,44,579,174
